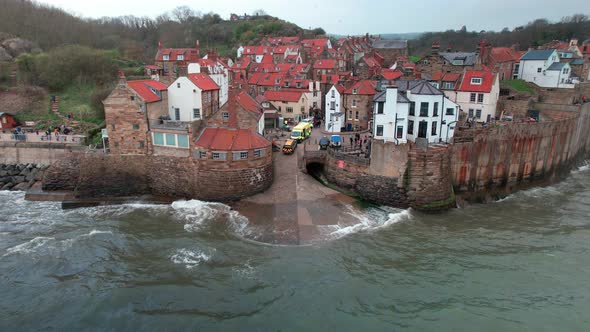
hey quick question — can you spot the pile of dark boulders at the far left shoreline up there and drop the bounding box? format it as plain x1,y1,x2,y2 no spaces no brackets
0,164,48,191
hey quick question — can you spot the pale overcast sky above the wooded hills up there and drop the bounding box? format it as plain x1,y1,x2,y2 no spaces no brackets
39,0,590,35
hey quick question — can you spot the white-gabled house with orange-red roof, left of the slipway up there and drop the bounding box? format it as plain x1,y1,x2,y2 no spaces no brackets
168,73,219,122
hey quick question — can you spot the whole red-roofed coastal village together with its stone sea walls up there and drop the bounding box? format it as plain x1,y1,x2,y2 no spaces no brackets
0,11,590,243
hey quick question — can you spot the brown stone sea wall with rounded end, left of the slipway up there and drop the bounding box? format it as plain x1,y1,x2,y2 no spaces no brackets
43,154,273,201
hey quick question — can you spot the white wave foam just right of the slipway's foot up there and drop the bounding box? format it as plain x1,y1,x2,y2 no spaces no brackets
319,207,412,239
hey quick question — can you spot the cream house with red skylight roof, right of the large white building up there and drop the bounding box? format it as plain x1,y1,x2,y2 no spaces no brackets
456,70,500,122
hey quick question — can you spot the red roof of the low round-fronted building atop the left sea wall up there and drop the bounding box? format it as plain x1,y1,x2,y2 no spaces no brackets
195,127,270,151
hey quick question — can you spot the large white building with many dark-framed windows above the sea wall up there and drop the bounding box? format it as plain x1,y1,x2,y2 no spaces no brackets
373,81,459,144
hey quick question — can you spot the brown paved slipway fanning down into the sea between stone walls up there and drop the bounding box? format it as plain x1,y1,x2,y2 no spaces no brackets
233,128,358,244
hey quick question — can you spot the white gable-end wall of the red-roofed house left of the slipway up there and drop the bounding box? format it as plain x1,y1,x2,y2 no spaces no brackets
168,76,203,122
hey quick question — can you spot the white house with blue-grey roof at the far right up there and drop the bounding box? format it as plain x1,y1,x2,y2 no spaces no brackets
518,50,574,88
